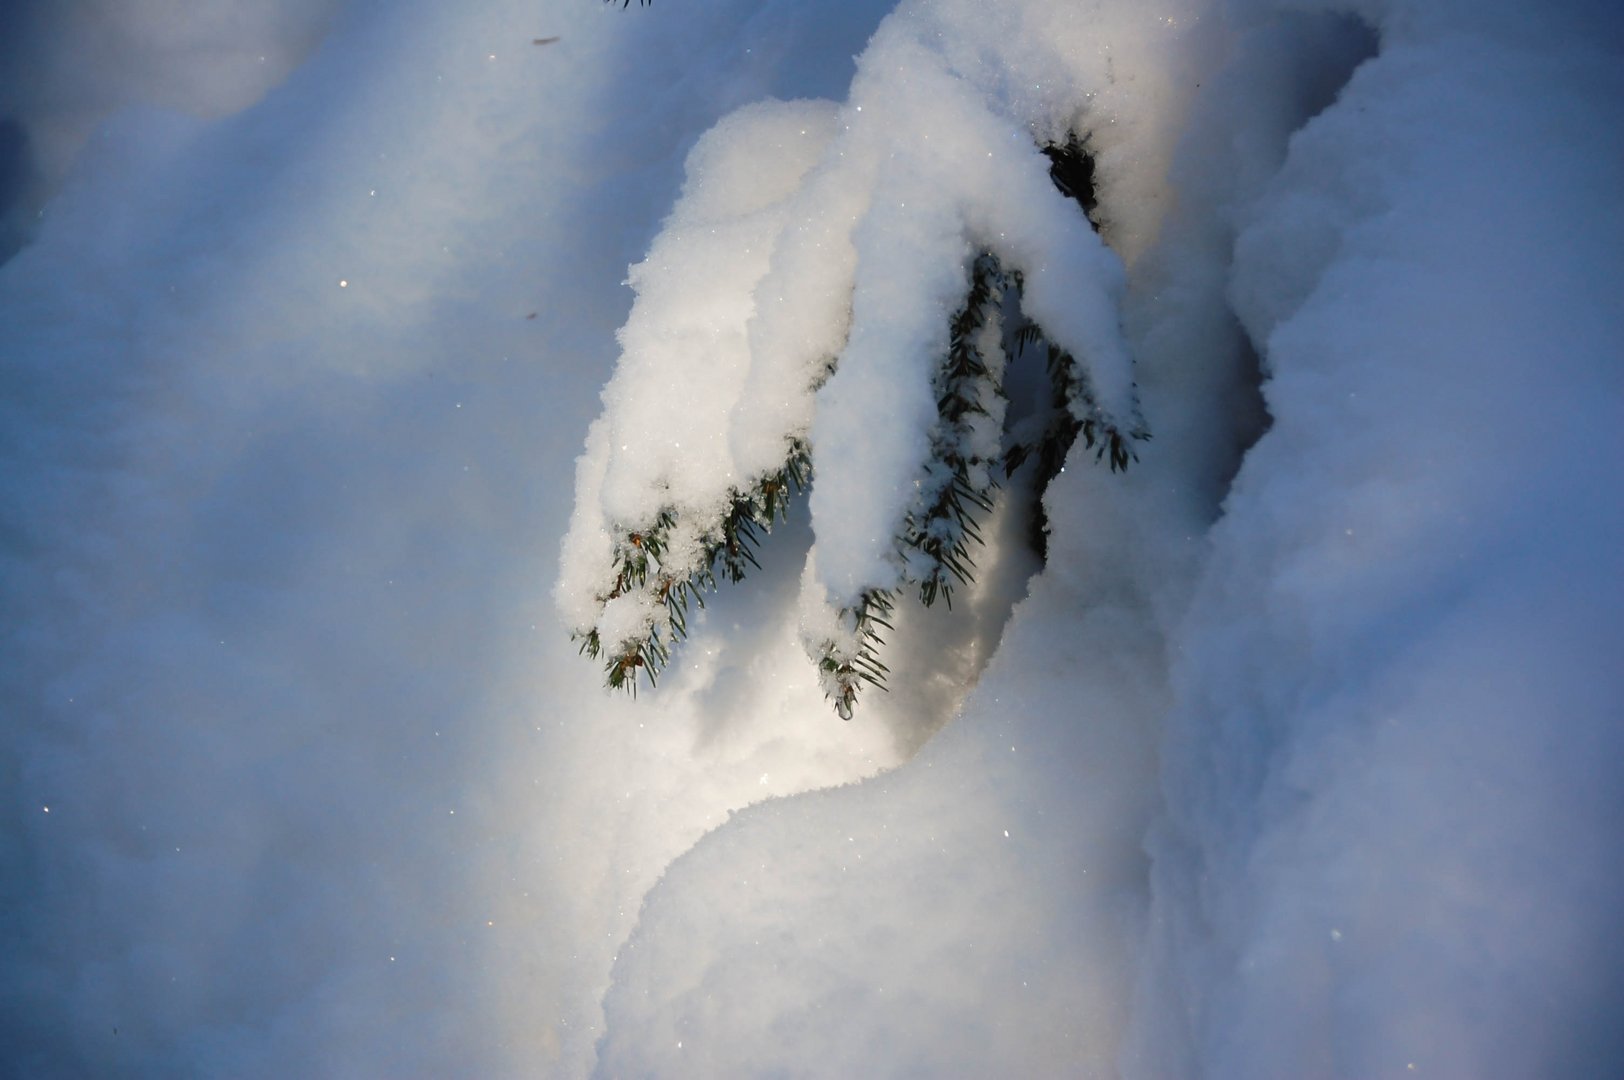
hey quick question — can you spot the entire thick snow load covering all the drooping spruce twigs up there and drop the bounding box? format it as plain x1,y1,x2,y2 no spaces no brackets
557,3,1155,698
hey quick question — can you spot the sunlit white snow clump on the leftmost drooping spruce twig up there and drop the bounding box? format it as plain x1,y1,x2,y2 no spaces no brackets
555,101,835,645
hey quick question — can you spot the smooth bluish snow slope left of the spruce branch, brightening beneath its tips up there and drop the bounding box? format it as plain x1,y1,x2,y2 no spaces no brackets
0,0,902,1077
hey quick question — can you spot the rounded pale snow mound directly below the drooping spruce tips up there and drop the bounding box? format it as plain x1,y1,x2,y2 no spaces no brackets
598,451,1166,1077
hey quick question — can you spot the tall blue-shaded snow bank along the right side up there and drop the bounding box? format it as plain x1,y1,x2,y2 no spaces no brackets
1135,5,1624,1077
